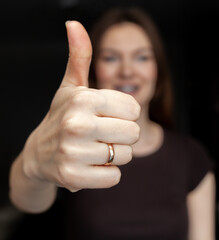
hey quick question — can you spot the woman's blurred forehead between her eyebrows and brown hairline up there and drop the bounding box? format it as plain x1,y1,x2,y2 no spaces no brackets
100,22,151,50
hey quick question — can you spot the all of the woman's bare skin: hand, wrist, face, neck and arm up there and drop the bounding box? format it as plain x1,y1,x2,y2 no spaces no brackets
10,19,215,240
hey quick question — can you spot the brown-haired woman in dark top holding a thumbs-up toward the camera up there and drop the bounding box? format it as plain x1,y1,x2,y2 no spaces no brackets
11,7,214,240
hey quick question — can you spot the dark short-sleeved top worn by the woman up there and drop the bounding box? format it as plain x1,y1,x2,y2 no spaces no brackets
61,130,212,240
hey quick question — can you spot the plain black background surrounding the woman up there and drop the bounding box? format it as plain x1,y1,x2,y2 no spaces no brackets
0,0,219,240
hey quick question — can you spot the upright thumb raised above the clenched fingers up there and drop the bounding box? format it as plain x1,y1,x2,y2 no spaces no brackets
61,21,92,87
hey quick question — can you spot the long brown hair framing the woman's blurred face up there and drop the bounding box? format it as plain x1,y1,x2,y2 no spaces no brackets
90,8,173,128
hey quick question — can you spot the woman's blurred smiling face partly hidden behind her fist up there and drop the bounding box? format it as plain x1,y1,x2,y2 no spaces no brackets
95,22,157,106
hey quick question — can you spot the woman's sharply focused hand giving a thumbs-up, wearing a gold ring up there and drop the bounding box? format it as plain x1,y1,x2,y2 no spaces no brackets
23,21,140,191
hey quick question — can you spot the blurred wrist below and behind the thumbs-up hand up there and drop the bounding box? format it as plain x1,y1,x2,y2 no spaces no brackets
9,152,57,213
